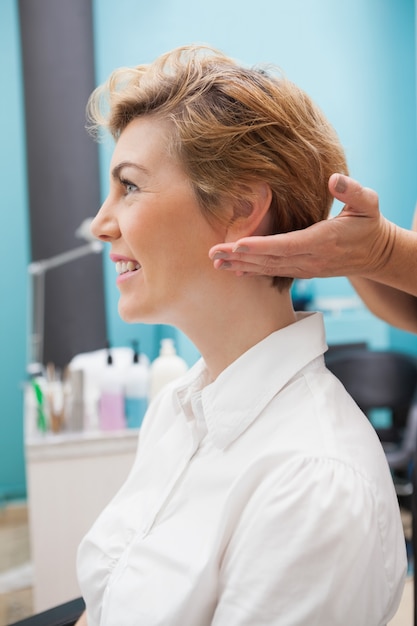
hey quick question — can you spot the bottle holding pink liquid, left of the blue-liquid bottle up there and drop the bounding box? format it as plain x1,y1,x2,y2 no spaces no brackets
99,349,126,430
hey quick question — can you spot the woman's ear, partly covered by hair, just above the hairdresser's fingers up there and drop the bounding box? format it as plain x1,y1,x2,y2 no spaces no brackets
225,182,272,242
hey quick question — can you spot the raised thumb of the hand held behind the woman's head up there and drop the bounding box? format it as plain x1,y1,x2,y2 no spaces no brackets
329,174,379,217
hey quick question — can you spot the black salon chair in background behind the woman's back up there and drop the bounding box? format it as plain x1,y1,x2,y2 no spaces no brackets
325,349,417,497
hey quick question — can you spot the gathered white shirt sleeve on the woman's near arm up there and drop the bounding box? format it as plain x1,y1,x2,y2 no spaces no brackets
212,458,406,626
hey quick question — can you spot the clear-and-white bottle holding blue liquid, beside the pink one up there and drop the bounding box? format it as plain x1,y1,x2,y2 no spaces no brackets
124,342,150,428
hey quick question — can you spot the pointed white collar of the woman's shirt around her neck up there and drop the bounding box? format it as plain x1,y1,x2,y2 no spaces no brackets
176,313,327,449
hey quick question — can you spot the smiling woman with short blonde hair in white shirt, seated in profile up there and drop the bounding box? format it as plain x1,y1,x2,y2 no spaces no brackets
78,47,406,626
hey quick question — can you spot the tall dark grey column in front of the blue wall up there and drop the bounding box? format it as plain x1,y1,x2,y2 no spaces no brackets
19,0,106,367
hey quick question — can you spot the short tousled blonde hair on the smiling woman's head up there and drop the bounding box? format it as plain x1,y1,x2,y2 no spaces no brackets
88,46,348,288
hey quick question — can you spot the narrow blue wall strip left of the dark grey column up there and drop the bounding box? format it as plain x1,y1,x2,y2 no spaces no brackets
0,0,29,503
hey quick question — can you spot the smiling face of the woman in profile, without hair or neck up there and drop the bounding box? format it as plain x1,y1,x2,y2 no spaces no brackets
92,117,225,328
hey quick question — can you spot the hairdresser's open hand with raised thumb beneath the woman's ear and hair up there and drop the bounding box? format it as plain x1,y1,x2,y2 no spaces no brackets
209,174,395,278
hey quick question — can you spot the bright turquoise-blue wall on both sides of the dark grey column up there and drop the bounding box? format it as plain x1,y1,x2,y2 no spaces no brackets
0,0,417,500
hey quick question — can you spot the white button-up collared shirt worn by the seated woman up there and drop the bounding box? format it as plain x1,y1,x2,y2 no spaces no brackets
78,314,406,626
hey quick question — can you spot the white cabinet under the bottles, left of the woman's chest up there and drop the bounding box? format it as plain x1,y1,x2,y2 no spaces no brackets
26,430,138,612
